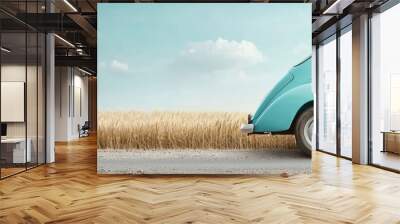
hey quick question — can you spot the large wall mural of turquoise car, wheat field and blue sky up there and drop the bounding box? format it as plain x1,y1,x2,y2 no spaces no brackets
98,3,313,174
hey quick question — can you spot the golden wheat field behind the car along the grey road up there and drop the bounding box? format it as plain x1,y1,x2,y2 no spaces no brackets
97,111,295,150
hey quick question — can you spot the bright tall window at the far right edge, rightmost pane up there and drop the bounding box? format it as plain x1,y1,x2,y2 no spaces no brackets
370,2,400,170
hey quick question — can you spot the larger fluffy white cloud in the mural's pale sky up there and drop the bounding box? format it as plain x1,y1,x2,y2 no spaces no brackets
174,38,265,72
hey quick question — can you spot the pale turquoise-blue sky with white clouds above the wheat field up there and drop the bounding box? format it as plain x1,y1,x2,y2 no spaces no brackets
98,3,311,113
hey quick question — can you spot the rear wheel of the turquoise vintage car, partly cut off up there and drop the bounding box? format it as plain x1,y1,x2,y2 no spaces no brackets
295,107,314,156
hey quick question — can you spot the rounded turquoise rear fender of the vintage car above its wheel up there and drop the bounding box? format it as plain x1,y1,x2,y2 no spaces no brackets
253,83,314,133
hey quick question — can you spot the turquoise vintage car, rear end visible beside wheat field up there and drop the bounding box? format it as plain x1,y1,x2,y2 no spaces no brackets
240,57,314,155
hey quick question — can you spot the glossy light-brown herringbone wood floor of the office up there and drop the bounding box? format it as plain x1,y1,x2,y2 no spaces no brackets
0,137,400,224
